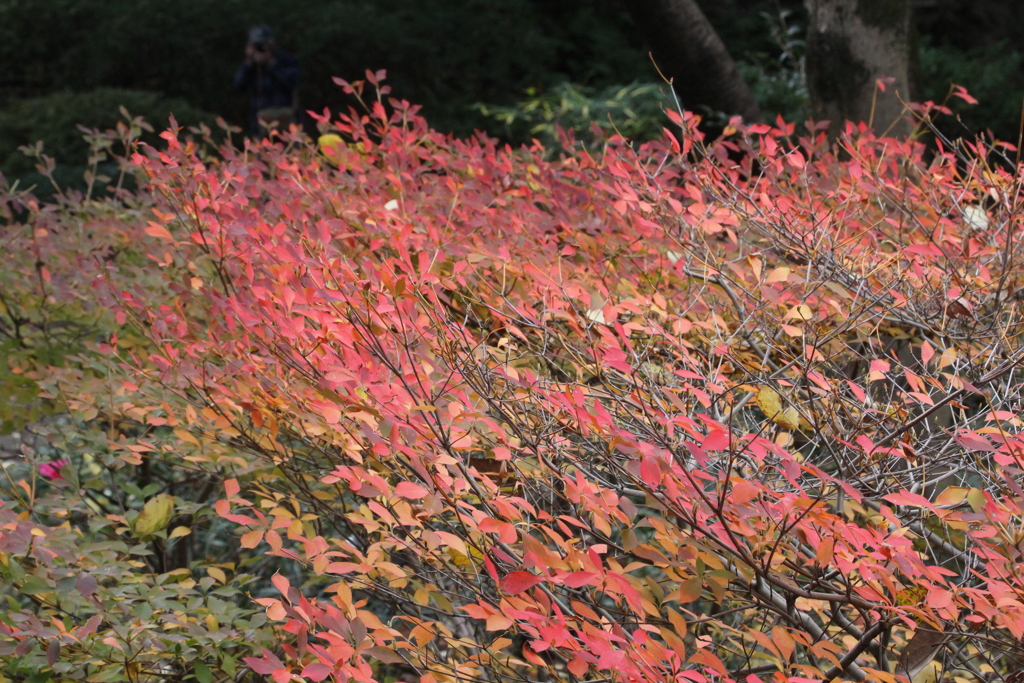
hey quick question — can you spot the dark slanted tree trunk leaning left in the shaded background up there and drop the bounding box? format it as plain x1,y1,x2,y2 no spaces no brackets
625,0,762,122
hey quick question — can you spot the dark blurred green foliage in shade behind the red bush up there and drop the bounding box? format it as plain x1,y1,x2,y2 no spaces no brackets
0,0,1024,183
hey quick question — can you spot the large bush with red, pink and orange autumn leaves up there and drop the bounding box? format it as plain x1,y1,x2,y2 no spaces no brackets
0,76,1024,683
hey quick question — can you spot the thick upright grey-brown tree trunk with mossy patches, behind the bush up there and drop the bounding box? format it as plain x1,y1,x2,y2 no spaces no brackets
806,0,912,135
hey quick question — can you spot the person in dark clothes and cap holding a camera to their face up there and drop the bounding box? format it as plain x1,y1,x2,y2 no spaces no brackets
234,26,300,135
